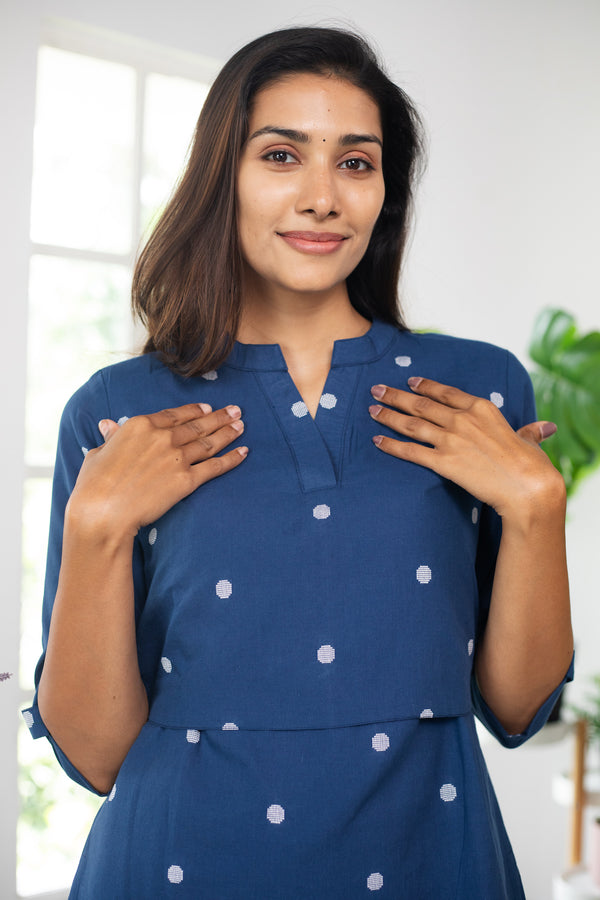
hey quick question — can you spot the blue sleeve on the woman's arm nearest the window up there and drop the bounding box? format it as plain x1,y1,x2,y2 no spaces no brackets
23,372,144,793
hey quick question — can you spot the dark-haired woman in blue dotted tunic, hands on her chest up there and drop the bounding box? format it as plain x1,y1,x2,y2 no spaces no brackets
28,28,573,900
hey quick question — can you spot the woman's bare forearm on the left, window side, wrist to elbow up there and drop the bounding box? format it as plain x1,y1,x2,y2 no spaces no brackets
38,510,148,792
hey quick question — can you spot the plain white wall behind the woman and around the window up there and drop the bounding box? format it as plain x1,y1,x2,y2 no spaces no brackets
0,0,600,900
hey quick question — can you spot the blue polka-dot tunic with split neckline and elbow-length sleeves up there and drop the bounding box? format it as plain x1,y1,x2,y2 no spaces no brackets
25,321,572,900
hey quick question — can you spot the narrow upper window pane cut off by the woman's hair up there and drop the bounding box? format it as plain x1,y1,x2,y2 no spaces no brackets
141,74,208,232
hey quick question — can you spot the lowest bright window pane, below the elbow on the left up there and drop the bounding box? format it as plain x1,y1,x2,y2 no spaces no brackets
17,723,102,896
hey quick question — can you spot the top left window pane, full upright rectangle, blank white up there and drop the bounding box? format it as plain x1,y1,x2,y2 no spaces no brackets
31,47,136,253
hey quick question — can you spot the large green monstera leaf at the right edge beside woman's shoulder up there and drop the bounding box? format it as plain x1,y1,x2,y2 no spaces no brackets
529,309,600,495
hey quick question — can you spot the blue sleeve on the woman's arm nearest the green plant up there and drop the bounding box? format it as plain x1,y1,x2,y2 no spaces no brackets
471,351,573,747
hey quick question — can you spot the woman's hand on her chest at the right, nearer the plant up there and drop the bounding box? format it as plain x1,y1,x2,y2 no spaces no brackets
369,378,564,519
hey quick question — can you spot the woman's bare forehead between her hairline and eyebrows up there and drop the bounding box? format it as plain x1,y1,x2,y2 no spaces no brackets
249,72,382,137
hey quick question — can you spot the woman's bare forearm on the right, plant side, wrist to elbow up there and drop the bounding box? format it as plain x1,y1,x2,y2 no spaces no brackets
475,480,573,734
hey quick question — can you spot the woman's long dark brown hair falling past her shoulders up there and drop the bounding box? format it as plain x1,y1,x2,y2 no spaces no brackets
132,27,423,375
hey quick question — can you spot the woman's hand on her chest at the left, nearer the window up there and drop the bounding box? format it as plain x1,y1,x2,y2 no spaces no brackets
67,403,248,539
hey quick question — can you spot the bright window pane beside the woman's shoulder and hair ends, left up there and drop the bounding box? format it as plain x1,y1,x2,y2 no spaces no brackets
26,256,131,466
